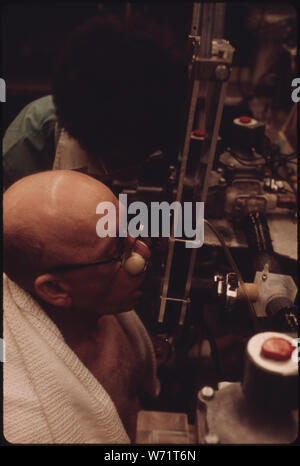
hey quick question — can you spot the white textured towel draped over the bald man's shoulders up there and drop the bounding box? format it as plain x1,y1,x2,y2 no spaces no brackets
3,276,157,444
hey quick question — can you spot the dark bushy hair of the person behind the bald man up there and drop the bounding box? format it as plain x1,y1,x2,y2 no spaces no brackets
53,14,187,168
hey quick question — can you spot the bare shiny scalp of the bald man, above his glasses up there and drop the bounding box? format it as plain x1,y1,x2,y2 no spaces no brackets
3,170,118,288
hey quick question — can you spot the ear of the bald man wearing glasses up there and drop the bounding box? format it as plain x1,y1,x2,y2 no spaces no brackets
34,273,72,307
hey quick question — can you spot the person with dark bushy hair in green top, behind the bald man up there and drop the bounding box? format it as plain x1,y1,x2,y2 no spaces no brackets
3,14,186,189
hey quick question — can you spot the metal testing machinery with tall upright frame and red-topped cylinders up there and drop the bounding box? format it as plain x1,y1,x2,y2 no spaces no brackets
112,3,298,444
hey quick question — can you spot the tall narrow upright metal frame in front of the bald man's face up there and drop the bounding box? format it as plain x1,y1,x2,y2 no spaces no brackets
158,3,234,325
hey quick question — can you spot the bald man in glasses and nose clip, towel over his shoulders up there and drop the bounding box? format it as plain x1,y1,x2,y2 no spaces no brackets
3,170,157,443
